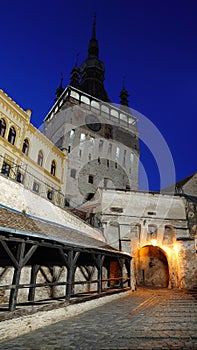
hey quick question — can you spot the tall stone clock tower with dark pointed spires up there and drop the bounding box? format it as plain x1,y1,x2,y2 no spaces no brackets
44,17,139,209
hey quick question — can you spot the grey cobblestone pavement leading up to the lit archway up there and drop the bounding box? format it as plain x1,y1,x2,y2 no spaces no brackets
0,288,197,350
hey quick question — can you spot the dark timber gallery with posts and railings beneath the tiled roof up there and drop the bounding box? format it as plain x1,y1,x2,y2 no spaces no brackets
0,232,131,311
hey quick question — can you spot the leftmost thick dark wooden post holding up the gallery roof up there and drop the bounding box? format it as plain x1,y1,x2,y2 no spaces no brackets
9,242,25,311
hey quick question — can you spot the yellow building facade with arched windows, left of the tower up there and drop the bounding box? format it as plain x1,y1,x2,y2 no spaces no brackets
0,90,66,206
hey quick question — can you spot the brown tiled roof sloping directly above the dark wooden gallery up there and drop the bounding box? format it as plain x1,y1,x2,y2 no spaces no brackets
0,205,121,252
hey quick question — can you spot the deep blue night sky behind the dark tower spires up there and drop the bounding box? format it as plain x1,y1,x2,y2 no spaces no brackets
0,0,197,190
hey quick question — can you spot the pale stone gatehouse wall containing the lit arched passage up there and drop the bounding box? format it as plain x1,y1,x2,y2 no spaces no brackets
97,190,197,288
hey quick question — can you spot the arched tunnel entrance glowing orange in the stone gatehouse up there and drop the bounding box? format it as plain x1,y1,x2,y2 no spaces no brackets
135,245,169,288
